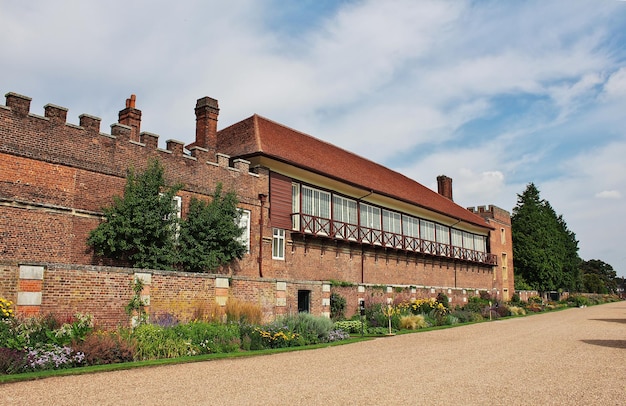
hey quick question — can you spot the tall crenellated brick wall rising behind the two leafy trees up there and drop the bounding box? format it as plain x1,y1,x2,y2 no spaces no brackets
0,93,267,272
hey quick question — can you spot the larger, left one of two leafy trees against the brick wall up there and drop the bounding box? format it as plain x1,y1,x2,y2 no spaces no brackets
87,160,182,270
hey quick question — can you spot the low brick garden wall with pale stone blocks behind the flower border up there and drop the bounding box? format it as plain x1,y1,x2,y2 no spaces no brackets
0,263,330,328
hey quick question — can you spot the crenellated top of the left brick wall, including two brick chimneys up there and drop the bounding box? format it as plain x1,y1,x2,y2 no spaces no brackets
0,92,255,175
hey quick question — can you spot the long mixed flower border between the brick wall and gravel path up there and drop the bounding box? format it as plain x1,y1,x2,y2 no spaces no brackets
0,291,619,383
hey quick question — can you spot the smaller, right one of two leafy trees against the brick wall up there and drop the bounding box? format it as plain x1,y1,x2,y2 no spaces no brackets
179,183,246,272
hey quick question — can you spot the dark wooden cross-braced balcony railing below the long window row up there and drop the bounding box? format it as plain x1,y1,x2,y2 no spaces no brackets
291,213,497,265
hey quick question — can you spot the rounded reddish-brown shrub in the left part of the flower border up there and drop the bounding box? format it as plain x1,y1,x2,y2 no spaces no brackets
73,331,136,365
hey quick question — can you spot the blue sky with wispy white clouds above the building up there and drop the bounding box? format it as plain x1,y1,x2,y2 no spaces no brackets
0,0,626,276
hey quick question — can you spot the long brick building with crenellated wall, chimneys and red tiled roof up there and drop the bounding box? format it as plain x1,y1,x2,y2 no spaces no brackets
0,93,513,324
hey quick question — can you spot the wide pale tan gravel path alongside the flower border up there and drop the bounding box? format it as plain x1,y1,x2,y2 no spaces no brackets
0,302,626,406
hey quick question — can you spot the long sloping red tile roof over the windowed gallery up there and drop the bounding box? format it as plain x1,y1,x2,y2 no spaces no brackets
217,114,492,228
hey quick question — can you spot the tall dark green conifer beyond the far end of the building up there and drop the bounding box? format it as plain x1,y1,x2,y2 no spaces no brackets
511,183,580,291
